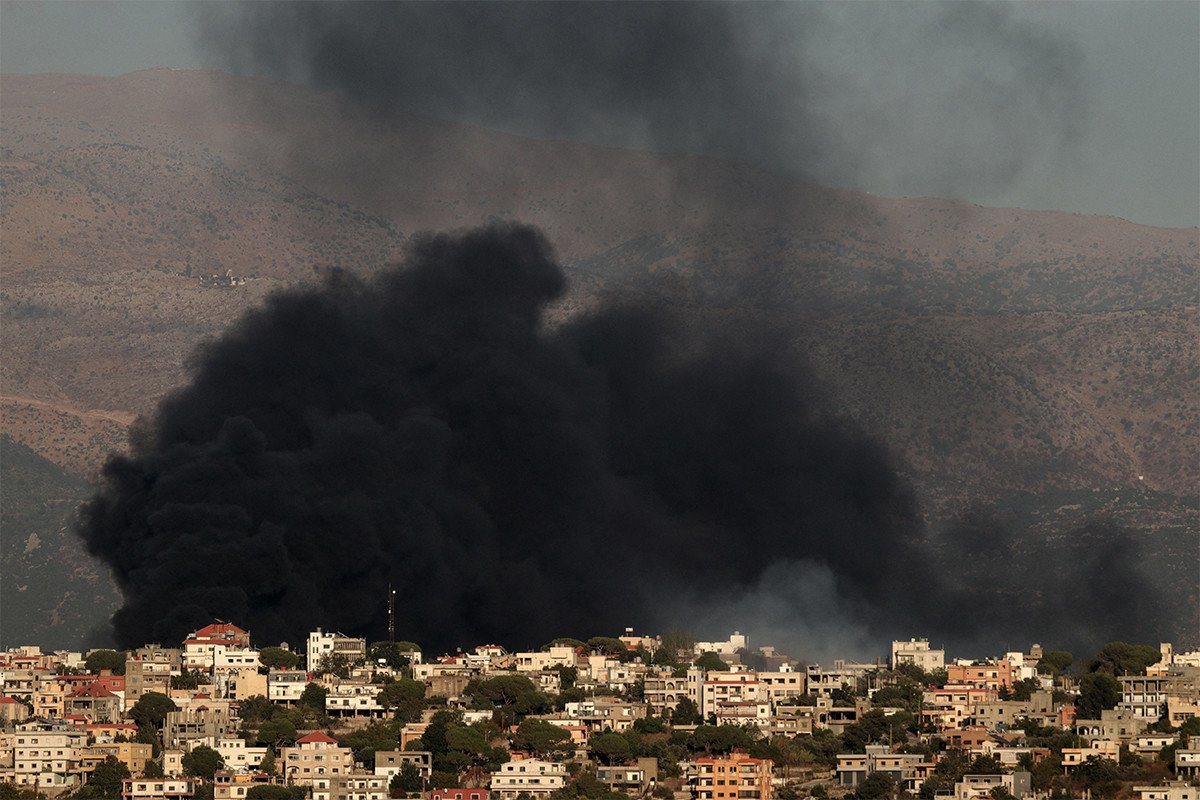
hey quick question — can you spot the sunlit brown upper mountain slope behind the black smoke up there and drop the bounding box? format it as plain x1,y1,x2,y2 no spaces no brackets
0,71,1198,506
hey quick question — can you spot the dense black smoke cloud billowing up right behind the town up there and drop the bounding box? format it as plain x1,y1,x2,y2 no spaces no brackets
83,227,1171,649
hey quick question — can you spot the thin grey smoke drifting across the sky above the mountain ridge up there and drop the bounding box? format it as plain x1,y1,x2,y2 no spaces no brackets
199,1,1087,197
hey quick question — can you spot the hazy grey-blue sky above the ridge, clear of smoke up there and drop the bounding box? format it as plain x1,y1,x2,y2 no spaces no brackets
0,0,1200,227
